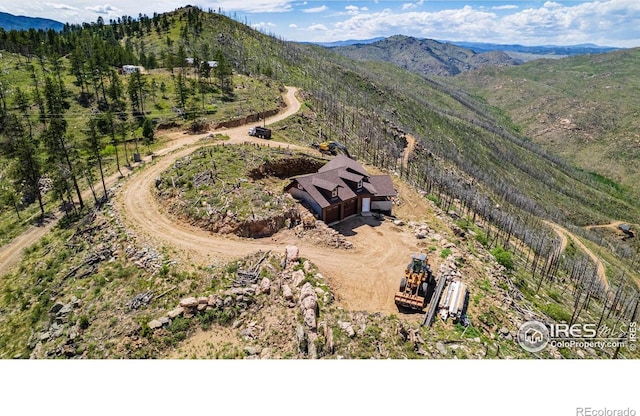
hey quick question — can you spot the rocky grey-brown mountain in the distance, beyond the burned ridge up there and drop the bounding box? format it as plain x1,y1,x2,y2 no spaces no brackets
331,35,523,76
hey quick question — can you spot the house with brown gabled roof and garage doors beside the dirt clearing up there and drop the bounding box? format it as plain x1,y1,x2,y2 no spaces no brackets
284,155,398,224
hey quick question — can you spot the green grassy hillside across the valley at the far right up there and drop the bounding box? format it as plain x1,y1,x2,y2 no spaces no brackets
452,49,640,203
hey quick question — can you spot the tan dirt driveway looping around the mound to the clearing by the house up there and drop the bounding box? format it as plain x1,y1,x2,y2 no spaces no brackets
116,89,436,320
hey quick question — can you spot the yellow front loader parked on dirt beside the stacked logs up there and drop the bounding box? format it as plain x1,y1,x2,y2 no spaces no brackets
394,254,435,311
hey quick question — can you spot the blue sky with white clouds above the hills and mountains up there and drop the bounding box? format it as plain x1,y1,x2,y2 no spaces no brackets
0,0,640,47
